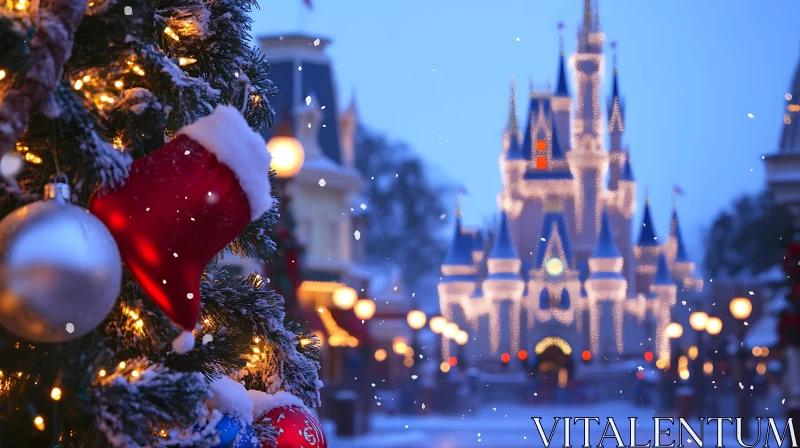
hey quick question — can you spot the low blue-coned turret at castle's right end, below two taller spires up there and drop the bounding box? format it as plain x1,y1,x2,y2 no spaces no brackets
648,252,678,359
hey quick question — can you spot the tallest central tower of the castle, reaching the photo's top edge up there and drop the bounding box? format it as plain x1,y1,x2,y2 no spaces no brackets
567,0,608,257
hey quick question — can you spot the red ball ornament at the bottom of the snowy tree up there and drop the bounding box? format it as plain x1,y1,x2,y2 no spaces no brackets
263,405,328,448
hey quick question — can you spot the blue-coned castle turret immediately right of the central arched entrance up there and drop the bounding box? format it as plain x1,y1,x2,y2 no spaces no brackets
585,211,628,355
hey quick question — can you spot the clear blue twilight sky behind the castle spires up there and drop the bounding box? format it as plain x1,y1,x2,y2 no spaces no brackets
254,0,800,270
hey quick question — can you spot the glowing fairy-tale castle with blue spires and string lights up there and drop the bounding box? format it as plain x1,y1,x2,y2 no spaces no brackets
439,0,703,368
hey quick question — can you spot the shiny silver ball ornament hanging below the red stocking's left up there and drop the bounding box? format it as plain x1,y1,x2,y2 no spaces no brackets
0,181,122,342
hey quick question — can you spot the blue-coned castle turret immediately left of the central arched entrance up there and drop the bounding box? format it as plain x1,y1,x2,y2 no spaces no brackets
483,212,525,353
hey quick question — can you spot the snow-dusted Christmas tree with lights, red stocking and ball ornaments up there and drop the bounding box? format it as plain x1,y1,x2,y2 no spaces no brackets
0,0,327,448
